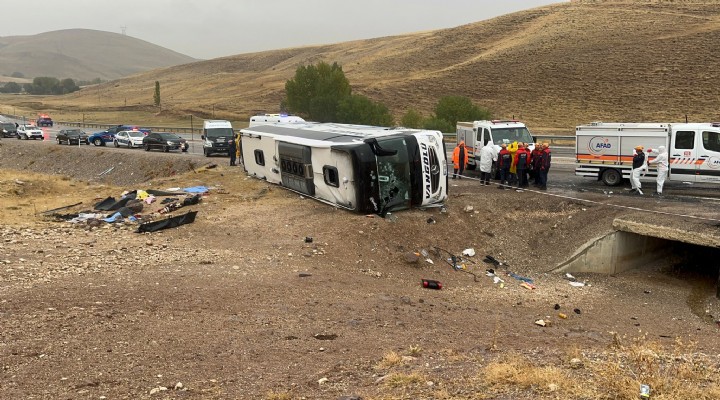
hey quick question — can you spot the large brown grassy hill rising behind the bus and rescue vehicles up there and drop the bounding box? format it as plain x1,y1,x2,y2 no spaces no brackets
25,1,720,133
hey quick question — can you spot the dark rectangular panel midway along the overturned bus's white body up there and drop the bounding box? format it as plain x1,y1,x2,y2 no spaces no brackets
278,142,315,196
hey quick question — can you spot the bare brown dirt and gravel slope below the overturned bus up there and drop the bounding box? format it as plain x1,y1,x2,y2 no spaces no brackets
0,141,720,400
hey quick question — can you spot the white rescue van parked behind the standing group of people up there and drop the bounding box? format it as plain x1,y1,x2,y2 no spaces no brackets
456,119,535,170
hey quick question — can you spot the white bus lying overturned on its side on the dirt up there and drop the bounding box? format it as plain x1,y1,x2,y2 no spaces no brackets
240,122,448,216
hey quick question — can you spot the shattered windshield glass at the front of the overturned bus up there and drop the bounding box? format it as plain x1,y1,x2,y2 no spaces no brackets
375,138,412,215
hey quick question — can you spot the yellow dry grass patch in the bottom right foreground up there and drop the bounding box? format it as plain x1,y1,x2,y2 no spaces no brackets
478,337,720,400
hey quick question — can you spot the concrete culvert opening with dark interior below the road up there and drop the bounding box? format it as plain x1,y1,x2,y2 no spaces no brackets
555,231,720,298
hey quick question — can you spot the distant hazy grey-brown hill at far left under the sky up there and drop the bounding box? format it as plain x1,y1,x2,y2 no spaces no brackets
0,29,196,80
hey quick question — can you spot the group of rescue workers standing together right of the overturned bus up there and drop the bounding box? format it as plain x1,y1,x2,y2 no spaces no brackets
453,141,552,190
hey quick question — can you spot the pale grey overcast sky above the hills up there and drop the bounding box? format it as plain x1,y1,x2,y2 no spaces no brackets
0,0,563,59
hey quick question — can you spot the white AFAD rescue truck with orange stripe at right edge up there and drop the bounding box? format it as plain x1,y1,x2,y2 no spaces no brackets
575,122,720,186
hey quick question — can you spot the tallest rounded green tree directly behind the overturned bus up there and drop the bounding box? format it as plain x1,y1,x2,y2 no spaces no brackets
285,61,352,122
